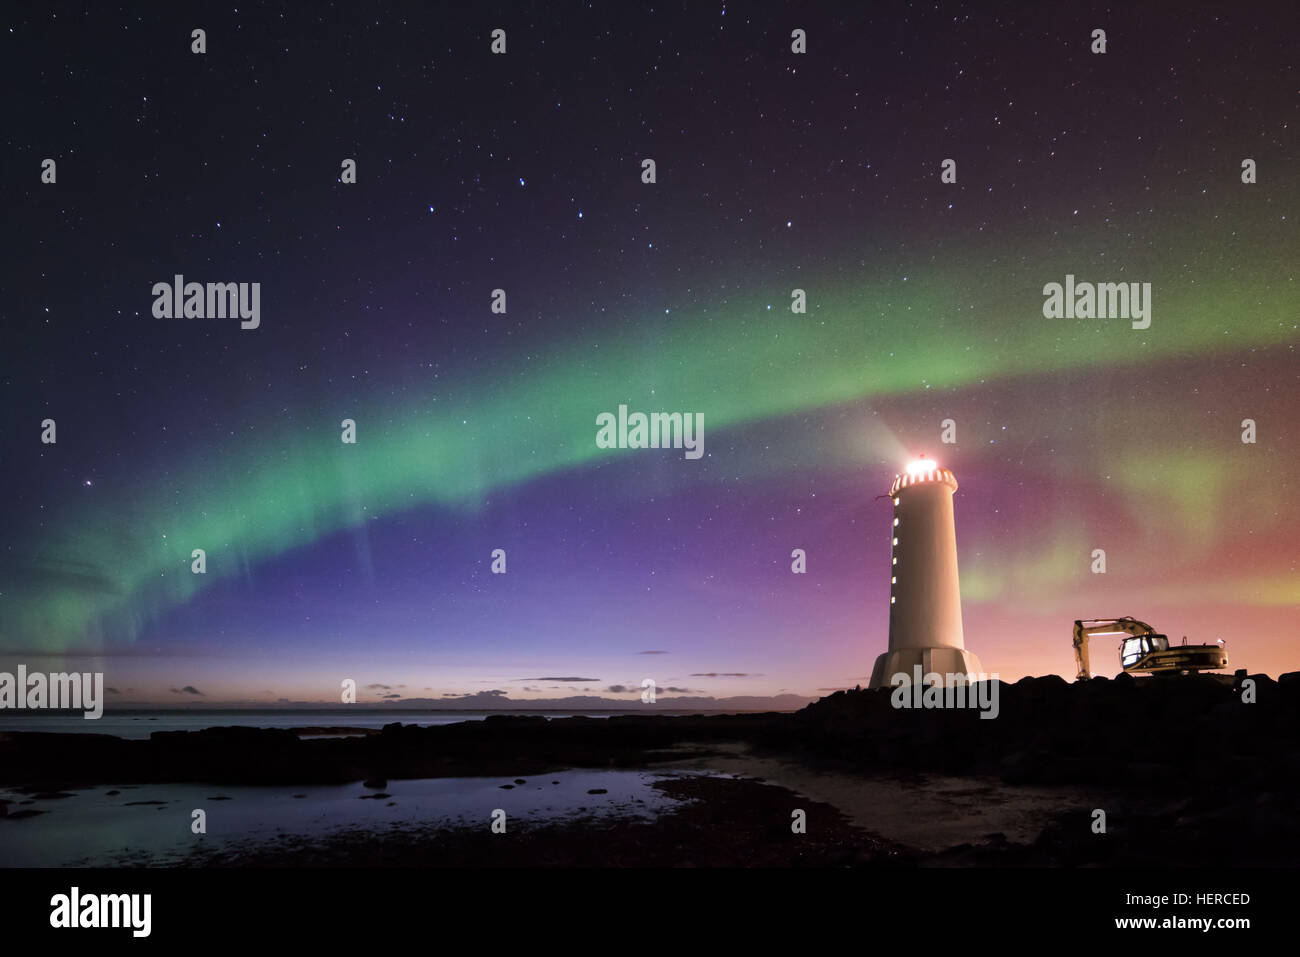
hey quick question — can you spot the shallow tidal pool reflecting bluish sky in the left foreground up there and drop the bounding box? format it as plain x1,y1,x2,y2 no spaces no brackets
0,769,722,867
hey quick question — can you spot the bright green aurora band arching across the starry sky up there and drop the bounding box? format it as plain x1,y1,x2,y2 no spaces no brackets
0,240,1297,653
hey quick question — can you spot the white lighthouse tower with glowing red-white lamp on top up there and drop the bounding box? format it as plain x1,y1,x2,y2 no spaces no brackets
870,455,980,688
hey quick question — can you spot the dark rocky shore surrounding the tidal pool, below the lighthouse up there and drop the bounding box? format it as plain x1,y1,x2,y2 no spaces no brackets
0,674,1300,866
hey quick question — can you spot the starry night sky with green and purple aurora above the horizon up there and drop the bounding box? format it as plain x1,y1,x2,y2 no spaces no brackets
0,3,1300,706
